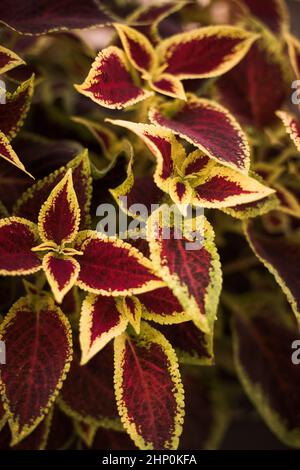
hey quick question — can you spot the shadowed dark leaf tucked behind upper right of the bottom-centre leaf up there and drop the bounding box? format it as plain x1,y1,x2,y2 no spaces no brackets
157,317,214,366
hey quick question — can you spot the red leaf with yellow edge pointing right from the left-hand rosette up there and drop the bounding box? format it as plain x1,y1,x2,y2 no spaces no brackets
75,230,164,296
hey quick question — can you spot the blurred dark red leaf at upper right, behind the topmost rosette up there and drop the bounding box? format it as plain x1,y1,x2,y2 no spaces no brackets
217,32,291,128
